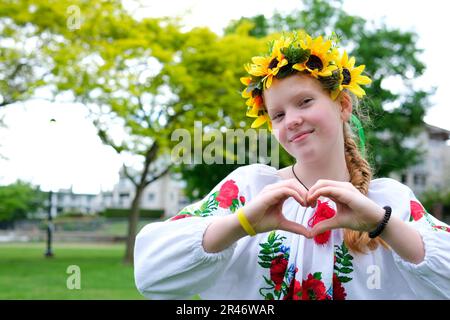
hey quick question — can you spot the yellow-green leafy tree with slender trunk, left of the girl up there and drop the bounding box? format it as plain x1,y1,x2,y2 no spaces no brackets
1,1,265,262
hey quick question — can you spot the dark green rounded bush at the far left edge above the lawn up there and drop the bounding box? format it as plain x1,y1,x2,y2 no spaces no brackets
0,181,46,222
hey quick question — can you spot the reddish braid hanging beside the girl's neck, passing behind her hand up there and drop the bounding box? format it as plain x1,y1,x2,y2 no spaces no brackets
344,123,388,253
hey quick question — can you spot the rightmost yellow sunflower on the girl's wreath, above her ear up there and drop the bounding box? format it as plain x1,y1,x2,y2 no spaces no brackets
331,51,372,100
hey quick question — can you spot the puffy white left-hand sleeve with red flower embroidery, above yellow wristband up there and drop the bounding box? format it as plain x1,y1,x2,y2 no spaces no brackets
134,167,251,299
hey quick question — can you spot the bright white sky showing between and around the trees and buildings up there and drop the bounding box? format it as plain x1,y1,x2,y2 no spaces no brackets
0,0,450,193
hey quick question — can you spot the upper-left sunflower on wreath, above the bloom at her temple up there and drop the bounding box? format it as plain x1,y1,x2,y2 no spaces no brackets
246,37,291,89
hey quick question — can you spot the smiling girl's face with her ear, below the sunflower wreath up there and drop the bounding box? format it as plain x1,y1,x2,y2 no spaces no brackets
264,74,351,163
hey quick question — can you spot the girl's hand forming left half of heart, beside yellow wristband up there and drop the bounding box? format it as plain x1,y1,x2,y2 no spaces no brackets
243,179,311,238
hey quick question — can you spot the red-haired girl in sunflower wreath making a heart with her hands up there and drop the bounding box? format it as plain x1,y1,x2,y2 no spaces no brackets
134,33,450,300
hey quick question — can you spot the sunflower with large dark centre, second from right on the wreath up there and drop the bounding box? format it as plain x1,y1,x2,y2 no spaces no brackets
292,35,337,78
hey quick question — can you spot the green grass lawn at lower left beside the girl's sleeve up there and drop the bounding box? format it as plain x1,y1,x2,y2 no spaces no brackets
0,243,144,300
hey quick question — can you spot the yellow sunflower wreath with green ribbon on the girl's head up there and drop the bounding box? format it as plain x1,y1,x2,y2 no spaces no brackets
241,31,372,137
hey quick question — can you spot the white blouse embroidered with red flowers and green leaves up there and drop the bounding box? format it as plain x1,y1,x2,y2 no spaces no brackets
134,164,450,300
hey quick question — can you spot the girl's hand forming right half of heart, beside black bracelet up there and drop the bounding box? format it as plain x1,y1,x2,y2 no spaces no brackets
306,180,384,236
